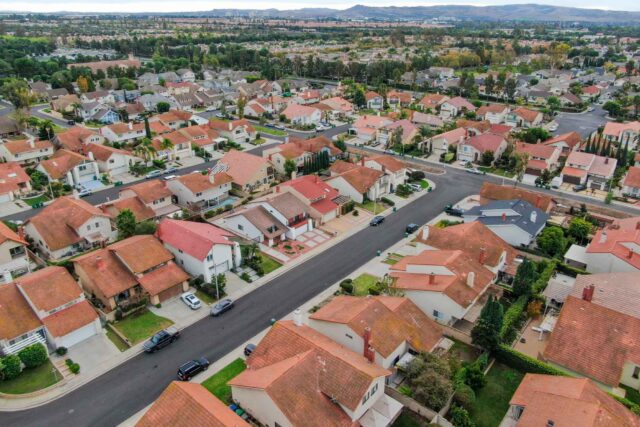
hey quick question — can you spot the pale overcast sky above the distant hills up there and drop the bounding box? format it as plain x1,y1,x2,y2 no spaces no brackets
0,0,640,12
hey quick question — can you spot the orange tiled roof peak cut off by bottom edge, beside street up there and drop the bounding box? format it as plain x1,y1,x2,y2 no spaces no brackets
135,381,250,427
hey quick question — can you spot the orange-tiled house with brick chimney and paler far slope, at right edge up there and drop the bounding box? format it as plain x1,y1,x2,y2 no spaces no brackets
542,273,640,395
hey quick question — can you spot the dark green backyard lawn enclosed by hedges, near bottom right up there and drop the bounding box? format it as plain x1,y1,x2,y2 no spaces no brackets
469,363,524,427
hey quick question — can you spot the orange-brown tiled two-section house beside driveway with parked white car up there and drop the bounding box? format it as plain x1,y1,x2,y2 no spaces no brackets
73,235,189,319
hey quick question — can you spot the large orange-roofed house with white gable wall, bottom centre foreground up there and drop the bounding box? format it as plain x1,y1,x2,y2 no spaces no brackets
228,318,402,427
